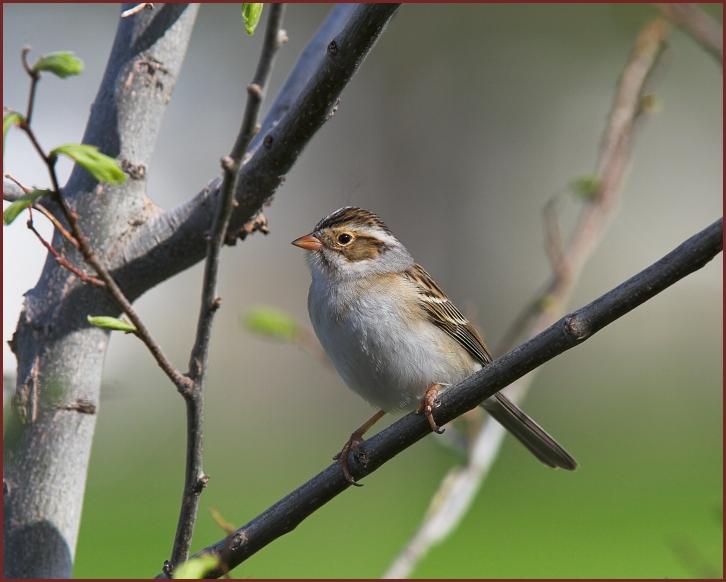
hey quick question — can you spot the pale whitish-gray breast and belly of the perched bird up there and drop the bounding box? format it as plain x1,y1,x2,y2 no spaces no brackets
308,275,479,412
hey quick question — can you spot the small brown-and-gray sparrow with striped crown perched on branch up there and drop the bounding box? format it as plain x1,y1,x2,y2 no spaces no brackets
292,206,577,485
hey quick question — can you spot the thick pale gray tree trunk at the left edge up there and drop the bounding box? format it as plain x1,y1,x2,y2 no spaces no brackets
4,4,197,578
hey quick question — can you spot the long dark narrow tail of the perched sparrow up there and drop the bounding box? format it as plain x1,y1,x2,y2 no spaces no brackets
482,392,577,471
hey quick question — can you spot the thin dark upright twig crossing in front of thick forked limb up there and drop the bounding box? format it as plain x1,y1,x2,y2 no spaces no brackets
167,4,284,571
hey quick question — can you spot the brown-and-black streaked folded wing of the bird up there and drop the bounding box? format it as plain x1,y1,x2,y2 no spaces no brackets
404,264,492,364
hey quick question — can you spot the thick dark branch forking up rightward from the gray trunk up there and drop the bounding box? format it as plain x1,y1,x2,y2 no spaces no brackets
105,4,398,306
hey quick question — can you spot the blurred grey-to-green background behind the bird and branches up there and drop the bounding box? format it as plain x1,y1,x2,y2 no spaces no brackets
3,4,722,578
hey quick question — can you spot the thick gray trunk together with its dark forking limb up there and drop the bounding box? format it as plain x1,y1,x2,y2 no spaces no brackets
4,4,398,578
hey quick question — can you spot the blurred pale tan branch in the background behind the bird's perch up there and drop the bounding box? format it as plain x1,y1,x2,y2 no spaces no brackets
383,20,668,578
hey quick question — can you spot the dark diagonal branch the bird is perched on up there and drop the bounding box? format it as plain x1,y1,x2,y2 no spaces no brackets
182,218,723,576
